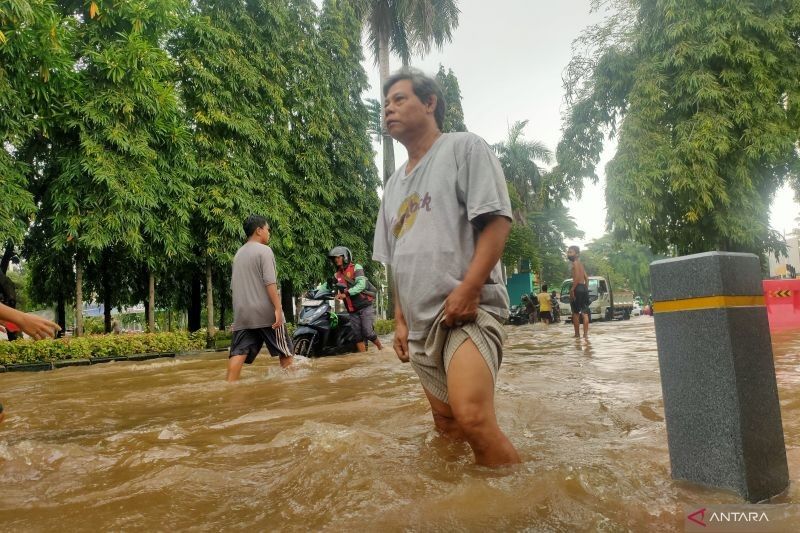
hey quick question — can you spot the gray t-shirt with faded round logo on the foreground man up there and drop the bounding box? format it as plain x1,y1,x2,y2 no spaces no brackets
372,133,511,340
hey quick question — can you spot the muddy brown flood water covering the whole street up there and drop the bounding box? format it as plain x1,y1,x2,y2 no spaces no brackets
0,317,800,531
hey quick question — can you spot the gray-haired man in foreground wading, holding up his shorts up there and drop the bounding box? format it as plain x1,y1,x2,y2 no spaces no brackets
373,70,520,465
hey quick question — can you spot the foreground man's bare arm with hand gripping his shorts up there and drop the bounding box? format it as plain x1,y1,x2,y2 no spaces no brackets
444,214,511,327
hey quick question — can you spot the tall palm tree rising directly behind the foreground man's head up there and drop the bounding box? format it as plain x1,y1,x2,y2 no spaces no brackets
357,0,460,184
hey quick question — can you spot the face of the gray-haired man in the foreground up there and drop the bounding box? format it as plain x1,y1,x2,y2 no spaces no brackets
383,80,436,142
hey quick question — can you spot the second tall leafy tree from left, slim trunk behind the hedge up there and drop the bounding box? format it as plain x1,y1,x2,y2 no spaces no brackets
42,0,189,334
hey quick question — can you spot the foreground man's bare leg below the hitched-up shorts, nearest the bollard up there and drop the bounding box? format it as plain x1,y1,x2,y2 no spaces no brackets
447,339,520,466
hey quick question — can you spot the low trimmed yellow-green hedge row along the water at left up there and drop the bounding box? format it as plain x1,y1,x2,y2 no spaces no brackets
0,332,205,365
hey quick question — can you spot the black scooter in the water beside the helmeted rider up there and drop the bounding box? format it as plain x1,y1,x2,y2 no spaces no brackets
292,284,356,357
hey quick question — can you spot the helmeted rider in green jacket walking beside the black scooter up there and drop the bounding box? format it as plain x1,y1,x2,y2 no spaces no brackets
328,246,383,352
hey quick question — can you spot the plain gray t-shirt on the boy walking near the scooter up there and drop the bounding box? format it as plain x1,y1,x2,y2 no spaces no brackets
231,241,278,331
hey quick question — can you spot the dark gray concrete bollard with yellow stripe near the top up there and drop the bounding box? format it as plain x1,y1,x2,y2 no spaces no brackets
650,252,789,502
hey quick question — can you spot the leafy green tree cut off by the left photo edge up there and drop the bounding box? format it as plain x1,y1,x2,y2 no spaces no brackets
0,0,76,273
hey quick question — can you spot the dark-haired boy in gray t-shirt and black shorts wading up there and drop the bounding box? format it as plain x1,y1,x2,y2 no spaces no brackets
227,215,292,382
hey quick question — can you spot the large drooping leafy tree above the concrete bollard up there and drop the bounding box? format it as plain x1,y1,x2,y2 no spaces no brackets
557,0,800,254
